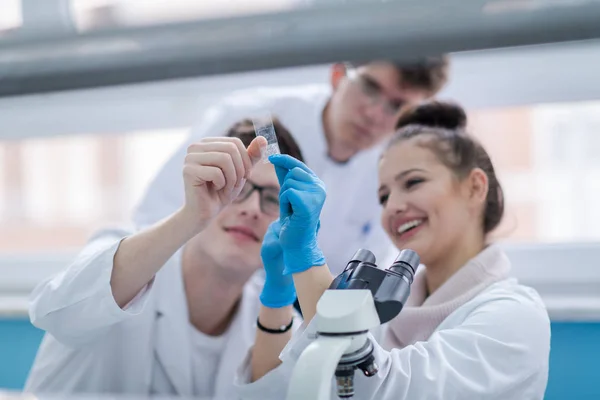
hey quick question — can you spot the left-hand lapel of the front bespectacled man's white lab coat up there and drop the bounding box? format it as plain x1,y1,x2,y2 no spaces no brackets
154,253,193,397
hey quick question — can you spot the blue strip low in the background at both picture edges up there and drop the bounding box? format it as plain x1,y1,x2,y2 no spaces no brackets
0,319,600,400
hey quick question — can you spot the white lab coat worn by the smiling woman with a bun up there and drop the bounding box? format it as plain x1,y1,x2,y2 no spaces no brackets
236,278,550,400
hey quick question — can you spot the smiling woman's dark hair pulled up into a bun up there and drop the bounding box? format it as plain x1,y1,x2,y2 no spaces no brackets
388,101,504,233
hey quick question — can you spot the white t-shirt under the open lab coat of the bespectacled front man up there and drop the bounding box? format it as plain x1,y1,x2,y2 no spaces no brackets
190,324,229,397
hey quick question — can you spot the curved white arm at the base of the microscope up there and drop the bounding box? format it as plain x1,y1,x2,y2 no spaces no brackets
287,336,352,400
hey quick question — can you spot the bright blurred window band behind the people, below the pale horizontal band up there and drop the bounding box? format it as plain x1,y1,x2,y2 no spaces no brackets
0,102,600,252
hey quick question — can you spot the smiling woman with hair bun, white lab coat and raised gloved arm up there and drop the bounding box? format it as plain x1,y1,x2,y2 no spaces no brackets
238,102,550,400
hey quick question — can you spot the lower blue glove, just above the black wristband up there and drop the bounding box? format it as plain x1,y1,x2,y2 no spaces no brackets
260,220,296,308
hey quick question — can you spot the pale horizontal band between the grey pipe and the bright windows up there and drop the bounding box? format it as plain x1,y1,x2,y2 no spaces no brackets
0,41,600,140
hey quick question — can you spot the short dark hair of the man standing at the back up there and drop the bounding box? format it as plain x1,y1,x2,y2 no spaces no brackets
353,55,450,97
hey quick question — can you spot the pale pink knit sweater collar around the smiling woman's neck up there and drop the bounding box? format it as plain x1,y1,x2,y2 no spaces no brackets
382,245,510,350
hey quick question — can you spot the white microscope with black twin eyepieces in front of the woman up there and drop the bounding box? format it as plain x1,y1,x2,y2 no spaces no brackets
287,249,420,400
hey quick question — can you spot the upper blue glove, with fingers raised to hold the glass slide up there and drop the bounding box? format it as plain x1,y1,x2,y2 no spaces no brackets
269,154,326,274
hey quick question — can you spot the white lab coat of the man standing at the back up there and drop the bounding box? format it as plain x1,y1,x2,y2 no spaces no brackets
134,85,394,274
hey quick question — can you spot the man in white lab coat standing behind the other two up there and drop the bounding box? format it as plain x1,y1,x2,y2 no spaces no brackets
134,56,449,274
